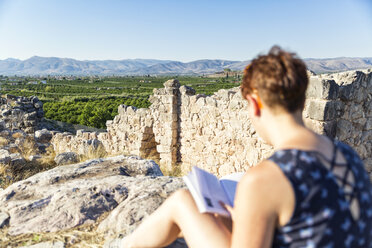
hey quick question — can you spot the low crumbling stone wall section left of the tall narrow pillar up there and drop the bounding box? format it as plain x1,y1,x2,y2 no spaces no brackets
51,105,158,160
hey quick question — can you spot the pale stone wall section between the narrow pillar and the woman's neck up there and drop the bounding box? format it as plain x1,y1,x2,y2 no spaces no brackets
180,86,272,175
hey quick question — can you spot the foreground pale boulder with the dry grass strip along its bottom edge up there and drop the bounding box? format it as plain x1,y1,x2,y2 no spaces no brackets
0,156,185,247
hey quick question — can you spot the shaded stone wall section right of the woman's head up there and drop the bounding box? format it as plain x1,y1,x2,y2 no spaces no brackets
304,70,372,179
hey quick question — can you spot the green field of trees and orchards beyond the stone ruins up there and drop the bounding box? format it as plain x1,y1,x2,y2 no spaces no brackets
0,76,240,128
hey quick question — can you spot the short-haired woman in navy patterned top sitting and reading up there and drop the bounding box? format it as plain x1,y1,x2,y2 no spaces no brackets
123,47,372,248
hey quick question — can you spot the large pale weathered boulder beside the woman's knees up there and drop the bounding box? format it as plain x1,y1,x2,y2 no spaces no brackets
0,156,184,235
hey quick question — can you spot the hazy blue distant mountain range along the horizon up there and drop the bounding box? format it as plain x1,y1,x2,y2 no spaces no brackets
0,56,372,75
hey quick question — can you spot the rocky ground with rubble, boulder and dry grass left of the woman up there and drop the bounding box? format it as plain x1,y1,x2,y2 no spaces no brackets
0,95,186,248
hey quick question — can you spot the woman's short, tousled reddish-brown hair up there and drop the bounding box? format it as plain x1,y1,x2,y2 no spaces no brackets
241,46,308,113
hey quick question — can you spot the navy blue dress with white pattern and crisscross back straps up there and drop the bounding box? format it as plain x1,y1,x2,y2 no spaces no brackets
269,141,372,248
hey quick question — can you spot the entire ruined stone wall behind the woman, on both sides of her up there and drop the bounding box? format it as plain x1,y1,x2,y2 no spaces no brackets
50,71,372,176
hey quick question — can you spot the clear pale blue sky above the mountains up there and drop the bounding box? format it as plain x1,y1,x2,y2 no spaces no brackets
0,0,372,62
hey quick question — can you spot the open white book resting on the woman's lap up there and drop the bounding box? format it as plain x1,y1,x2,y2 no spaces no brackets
183,167,244,217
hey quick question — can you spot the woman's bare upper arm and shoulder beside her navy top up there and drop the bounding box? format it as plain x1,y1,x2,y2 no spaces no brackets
231,161,295,248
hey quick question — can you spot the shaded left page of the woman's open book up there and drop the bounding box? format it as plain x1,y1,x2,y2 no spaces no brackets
193,167,230,216
